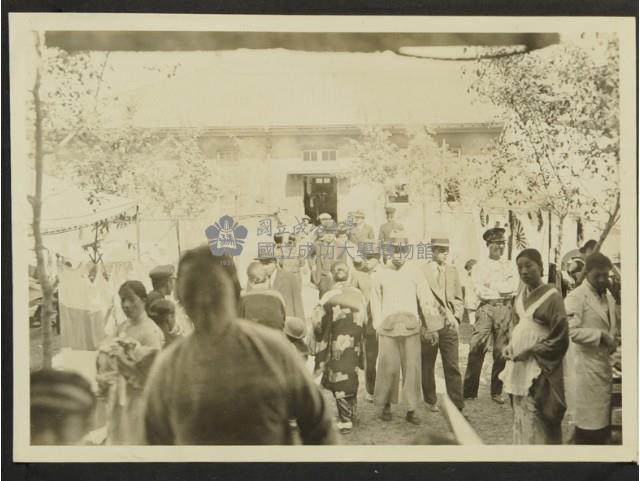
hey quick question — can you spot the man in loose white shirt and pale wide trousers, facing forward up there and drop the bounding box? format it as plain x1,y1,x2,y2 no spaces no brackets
370,239,443,424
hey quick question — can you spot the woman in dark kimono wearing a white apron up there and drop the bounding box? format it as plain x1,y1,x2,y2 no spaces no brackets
500,249,569,444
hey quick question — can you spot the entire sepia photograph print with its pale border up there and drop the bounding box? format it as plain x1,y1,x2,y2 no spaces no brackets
9,14,638,462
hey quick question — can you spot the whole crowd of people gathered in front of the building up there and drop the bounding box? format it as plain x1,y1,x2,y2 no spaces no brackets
31,208,620,445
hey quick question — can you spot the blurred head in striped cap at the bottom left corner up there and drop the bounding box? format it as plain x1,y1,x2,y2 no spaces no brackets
30,370,96,446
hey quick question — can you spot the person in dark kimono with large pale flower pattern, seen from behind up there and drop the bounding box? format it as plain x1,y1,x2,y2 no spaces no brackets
314,261,366,434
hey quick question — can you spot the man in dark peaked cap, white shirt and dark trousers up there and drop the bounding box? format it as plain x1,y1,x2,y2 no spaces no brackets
463,227,520,404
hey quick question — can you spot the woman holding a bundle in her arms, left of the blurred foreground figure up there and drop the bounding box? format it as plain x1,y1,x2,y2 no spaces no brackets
97,281,164,445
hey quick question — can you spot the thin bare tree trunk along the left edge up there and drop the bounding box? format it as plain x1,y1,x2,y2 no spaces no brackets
29,32,55,369
